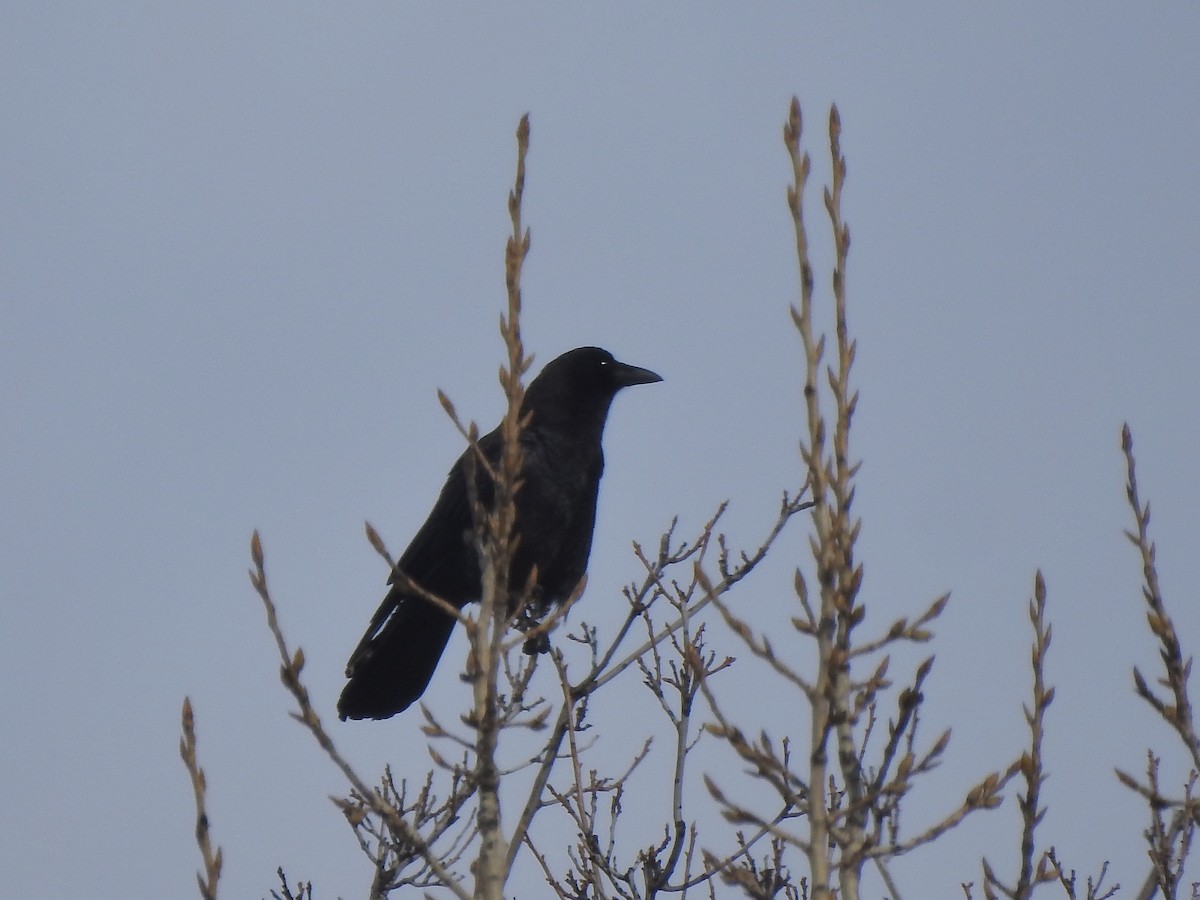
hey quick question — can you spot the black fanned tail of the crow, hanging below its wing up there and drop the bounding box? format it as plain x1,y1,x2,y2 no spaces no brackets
337,587,455,720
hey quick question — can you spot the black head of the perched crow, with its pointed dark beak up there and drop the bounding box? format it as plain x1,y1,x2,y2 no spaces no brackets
523,347,662,427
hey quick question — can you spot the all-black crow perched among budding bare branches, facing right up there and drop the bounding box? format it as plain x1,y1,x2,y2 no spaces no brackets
337,347,662,720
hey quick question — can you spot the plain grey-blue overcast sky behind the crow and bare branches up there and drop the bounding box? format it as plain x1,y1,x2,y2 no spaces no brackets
0,7,1200,898
